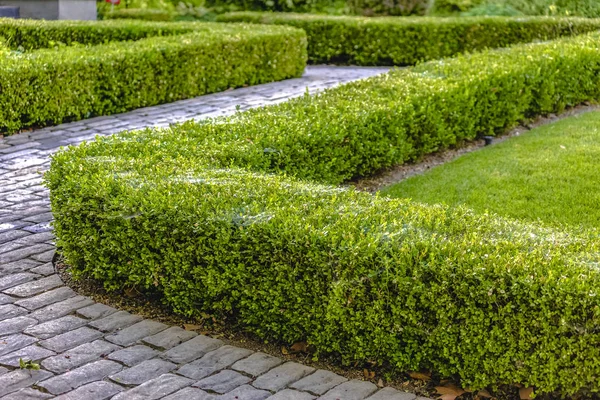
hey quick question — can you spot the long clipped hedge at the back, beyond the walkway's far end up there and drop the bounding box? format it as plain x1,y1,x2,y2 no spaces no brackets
217,12,600,65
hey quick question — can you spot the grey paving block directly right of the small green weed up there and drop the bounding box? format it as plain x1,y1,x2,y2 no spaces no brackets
42,340,120,374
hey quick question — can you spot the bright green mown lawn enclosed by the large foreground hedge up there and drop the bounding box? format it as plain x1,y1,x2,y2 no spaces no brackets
382,112,600,228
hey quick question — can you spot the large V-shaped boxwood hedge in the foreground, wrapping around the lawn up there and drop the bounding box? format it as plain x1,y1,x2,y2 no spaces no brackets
46,34,600,394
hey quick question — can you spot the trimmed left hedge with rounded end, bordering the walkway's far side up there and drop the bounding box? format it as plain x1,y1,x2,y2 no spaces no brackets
0,24,306,133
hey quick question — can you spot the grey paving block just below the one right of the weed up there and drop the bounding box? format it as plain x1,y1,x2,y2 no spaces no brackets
38,360,123,395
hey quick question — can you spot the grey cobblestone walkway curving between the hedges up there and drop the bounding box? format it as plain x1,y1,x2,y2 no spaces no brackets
0,67,428,400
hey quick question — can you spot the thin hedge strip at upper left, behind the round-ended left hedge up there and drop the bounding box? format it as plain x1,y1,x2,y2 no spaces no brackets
0,18,197,50
